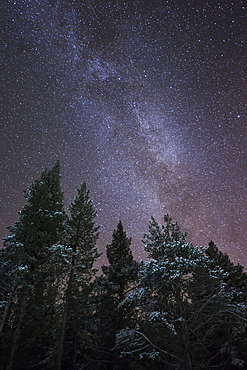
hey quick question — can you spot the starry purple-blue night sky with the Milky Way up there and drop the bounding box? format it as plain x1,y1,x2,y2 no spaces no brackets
0,0,247,266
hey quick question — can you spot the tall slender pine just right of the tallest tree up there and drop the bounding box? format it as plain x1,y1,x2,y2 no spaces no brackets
56,183,99,369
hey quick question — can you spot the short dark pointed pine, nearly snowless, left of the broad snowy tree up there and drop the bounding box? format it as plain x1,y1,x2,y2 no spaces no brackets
93,221,139,369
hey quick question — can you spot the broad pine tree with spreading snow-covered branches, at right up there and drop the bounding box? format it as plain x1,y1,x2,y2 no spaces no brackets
116,215,246,370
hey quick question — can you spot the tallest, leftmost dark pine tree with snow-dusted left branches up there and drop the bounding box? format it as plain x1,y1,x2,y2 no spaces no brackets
0,162,65,370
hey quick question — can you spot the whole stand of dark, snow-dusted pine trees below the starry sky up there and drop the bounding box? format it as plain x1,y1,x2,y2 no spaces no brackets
0,162,247,370
